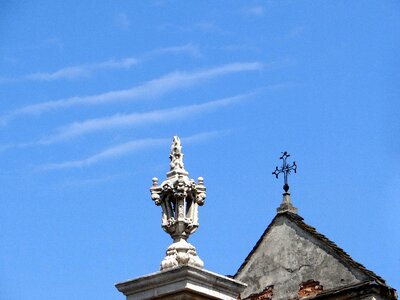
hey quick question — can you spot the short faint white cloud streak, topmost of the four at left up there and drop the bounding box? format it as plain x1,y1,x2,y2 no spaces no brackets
26,57,138,81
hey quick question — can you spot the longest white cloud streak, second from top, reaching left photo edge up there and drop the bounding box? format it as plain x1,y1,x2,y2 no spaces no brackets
0,62,263,124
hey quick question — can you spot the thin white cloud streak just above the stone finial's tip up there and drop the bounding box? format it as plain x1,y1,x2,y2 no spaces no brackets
36,93,250,145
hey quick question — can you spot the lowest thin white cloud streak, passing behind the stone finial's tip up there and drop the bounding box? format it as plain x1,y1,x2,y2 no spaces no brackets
38,130,223,171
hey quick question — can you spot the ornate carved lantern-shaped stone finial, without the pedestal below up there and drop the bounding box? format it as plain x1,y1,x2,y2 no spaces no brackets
150,136,206,271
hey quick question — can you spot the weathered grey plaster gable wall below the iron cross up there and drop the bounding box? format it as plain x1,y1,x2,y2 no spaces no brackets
235,214,368,300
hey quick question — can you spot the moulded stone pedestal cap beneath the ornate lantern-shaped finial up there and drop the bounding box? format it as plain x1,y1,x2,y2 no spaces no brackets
115,265,246,300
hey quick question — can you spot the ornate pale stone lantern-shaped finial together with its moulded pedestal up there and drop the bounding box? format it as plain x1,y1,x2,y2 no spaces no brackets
116,136,246,300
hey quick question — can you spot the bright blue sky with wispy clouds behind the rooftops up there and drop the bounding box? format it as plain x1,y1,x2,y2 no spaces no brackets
0,0,400,300
